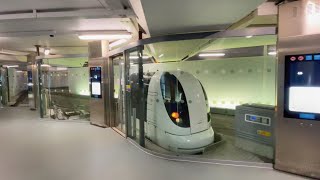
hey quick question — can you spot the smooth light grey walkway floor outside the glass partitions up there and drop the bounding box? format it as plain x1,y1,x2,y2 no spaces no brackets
0,107,303,180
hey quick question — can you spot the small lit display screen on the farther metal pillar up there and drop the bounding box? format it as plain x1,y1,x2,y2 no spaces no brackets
90,67,102,98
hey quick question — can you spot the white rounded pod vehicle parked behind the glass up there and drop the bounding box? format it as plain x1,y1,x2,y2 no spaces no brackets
146,71,214,154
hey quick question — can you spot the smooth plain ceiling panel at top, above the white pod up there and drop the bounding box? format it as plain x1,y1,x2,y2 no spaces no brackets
141,0,265,36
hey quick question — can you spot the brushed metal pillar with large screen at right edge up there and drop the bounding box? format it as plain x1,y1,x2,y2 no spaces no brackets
275,0,320,178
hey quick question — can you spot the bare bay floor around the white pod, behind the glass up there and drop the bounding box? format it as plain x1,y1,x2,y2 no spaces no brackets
146,114,272,163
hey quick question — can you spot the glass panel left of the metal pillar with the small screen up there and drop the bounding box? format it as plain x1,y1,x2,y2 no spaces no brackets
41,58,90,121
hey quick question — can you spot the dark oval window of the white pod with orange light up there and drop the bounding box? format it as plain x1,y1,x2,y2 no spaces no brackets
160,73,190,128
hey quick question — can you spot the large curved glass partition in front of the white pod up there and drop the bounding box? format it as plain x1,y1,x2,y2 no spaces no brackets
114,30,277,163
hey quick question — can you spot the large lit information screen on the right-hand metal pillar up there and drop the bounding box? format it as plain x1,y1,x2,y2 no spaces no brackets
284,53,320,120
